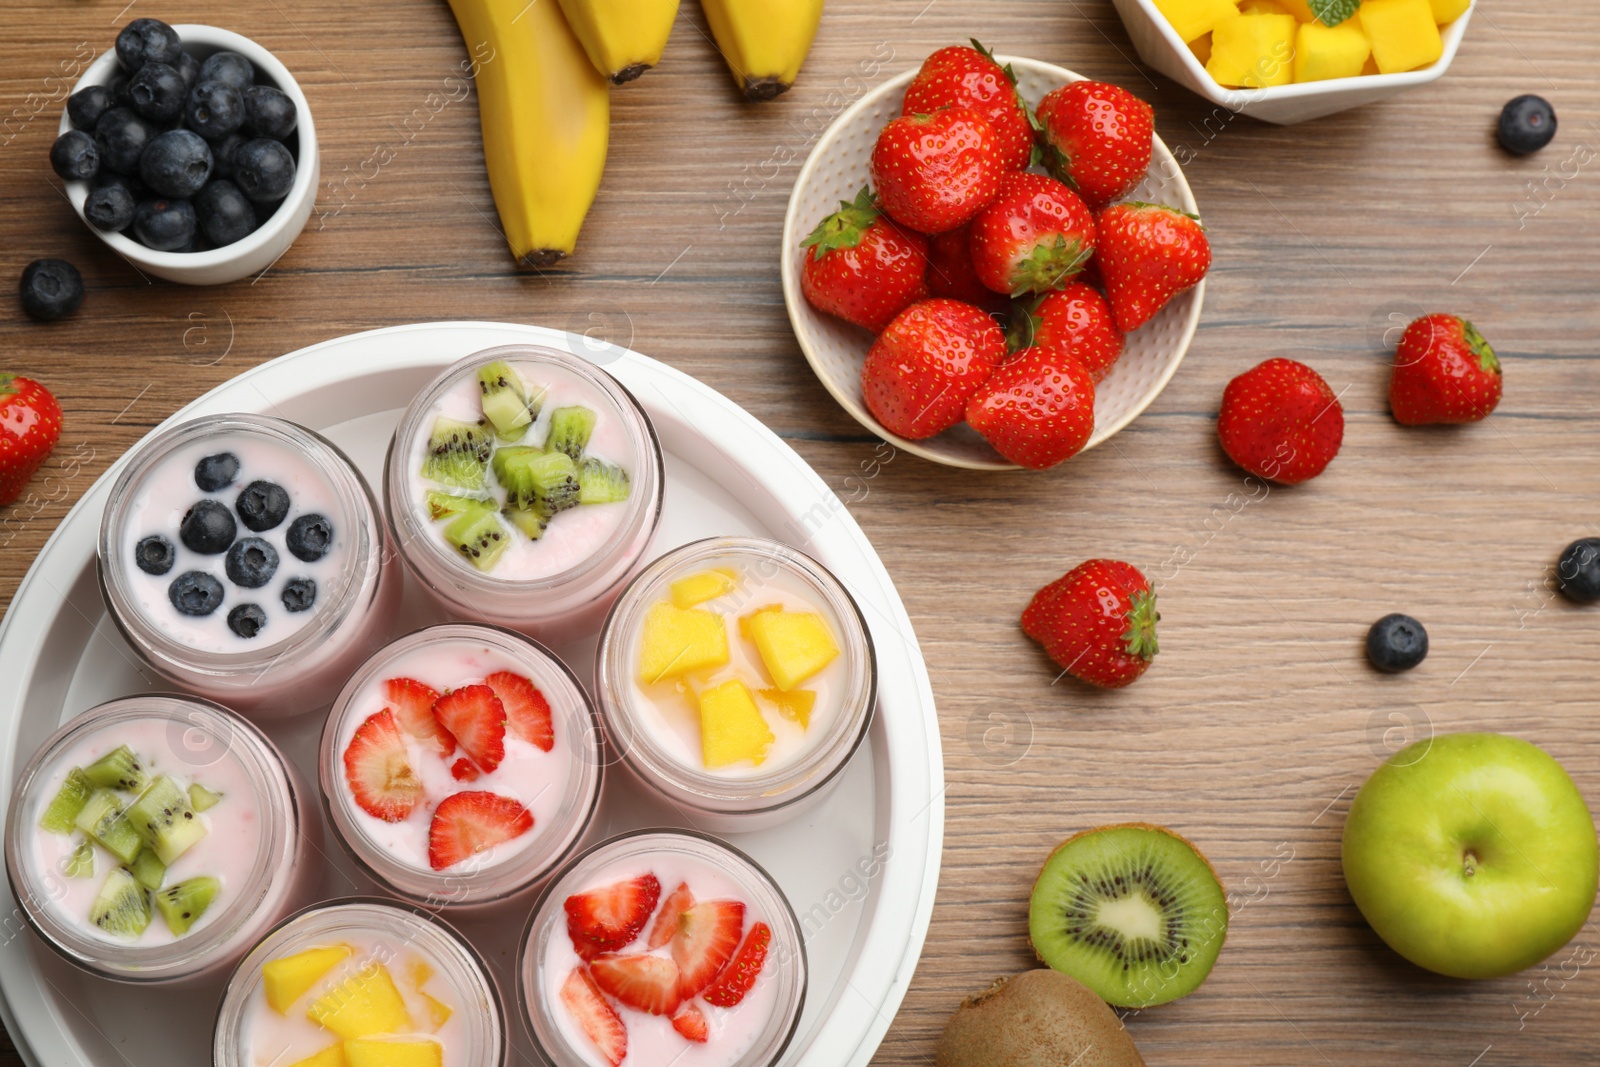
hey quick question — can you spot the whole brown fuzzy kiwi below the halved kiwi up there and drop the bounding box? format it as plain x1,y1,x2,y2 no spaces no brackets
934,968,1144,1067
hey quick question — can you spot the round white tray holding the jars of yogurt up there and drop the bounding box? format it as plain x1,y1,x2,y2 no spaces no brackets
0,323,944,1067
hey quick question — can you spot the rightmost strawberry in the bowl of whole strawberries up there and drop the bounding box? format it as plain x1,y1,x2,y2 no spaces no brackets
1094,200,1211,333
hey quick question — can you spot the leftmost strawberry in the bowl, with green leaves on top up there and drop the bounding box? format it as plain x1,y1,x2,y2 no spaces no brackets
800,186,928,333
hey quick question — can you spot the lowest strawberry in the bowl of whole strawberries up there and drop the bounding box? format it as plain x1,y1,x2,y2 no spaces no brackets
966,349,1094,470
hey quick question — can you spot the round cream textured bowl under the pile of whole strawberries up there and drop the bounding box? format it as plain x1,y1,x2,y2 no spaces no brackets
782,56,1205,470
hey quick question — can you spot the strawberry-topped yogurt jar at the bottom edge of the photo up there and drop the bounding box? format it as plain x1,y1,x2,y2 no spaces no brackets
517,830,806,1067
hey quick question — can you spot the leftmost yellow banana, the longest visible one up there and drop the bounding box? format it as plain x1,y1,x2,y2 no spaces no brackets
450,0,611,267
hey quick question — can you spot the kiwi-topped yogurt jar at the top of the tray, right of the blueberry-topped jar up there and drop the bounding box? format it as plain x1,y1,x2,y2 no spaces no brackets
384,346,664,637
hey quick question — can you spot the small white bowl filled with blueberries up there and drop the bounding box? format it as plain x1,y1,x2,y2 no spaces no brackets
50,19,322,285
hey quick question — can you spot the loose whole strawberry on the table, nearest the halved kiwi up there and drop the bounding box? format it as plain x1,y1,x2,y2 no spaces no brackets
1022,560,1162,689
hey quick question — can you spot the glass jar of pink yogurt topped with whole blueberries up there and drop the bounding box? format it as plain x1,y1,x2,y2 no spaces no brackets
98,414,400,717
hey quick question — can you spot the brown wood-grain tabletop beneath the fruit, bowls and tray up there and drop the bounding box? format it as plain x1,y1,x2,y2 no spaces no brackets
0,0,1600,1067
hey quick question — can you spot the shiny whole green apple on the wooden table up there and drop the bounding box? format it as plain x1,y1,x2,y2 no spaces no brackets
1344,733,1600,977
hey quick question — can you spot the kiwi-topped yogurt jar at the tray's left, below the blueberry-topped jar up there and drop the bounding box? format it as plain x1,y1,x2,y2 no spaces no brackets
5,694,322,982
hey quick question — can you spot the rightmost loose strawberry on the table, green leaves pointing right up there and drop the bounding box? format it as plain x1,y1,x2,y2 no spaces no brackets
1389,315,1502,426
